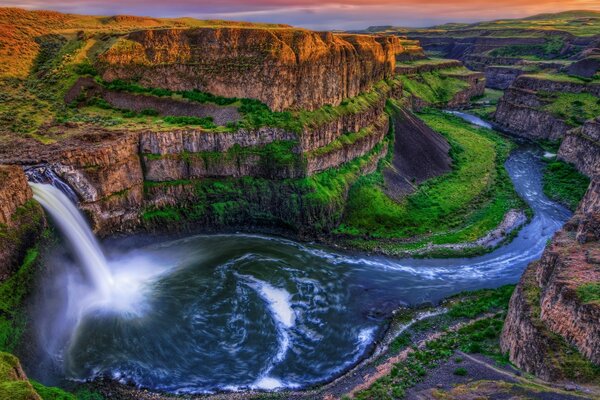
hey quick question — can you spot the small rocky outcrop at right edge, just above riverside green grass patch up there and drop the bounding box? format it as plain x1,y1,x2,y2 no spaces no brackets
558,117,600,176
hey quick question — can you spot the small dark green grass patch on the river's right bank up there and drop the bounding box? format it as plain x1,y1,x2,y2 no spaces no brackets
542,160,590,211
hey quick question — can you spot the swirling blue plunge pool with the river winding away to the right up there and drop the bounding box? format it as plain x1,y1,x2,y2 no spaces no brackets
26,141,569,393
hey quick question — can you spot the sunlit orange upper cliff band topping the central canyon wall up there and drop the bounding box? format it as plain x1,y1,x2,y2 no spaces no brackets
98,28,403,111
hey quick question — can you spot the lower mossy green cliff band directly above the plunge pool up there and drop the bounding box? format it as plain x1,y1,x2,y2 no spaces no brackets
142,144,387,234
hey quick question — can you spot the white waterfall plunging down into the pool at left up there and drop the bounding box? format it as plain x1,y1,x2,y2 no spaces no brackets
29,180,113,298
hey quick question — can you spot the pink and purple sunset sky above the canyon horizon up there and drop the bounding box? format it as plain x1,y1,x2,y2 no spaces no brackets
0,0,600,30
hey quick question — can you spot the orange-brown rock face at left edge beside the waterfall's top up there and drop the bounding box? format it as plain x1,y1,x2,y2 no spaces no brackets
0,165,44,281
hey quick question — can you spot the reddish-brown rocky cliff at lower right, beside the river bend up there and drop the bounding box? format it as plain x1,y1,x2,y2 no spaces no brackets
501,177,600,381
